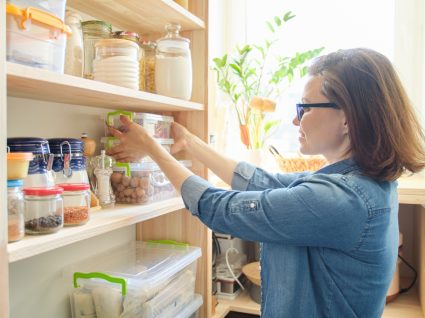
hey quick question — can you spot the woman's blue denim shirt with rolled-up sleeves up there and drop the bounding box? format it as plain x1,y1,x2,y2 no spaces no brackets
181,159,398,318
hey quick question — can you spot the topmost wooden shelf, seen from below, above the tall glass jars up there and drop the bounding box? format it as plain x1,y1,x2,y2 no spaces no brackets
67,0,205,35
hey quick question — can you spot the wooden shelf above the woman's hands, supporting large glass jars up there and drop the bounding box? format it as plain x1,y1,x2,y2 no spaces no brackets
7,62,204,112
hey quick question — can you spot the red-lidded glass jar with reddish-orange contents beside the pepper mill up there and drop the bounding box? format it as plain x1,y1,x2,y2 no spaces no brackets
58,183,90,226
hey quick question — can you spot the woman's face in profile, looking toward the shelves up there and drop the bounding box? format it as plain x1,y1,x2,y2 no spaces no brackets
292,76,350,163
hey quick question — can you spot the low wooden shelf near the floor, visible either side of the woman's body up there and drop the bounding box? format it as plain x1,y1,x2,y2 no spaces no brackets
212,290,424,318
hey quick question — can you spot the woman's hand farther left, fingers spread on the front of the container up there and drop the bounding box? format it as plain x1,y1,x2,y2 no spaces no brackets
108,116,157,162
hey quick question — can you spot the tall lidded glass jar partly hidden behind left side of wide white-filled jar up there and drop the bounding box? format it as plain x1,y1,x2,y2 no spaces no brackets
81,20,112,79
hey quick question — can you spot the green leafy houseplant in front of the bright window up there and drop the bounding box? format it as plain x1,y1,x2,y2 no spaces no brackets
213,11,323,149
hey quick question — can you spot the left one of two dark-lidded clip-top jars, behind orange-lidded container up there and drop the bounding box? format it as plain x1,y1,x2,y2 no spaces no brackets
7,137,55,188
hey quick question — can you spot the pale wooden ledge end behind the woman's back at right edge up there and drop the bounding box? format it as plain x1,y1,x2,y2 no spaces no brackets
398,176,425,204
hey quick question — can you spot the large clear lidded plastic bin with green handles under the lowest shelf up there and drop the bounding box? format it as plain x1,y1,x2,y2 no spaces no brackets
70,241,201,318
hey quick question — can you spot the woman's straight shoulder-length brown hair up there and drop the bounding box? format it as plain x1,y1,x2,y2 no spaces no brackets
309,48,425,180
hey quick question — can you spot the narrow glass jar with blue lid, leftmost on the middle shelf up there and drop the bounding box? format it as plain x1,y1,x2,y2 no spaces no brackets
7,180,25,243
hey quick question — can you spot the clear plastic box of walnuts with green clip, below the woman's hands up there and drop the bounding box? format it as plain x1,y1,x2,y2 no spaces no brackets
111,160,192,204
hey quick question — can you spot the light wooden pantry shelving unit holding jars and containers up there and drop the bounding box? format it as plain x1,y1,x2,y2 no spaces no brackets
0,0,212,318
